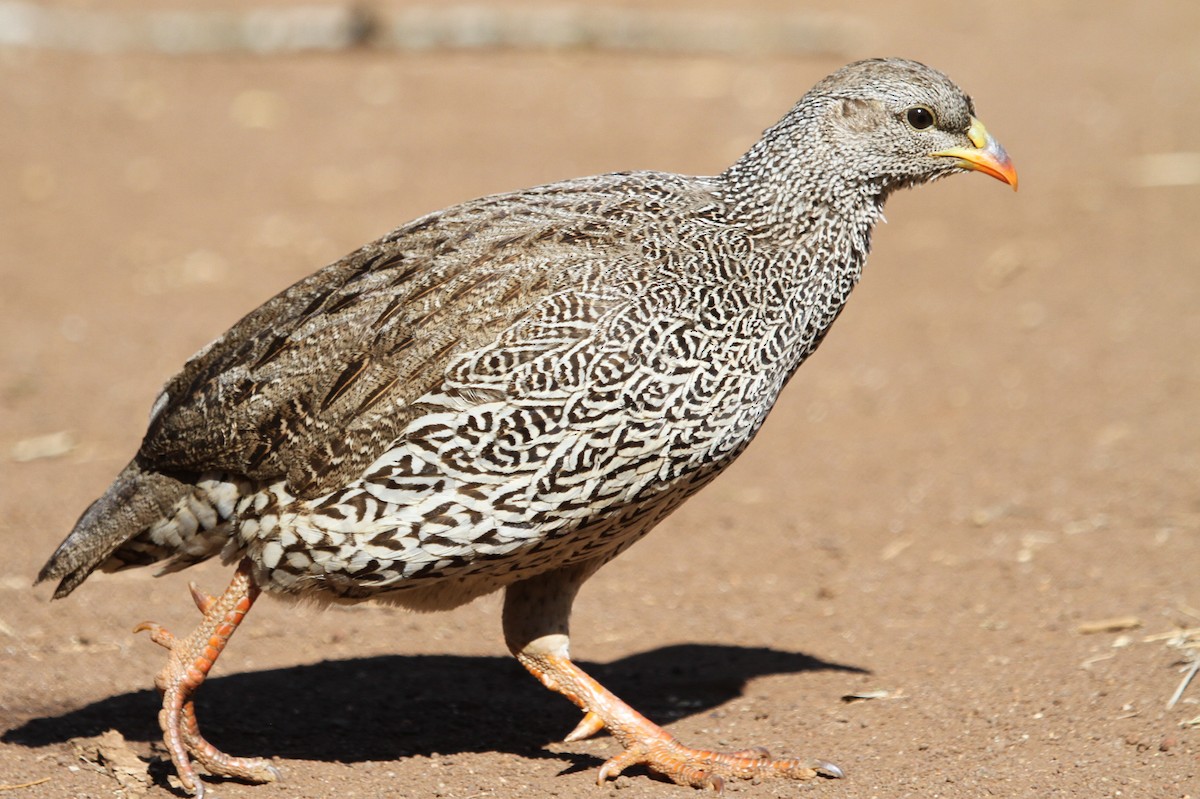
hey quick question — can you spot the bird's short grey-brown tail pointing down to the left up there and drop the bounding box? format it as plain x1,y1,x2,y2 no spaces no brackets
37,461,188,599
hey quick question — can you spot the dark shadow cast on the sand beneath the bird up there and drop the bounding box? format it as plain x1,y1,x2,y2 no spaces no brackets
0,644,864,765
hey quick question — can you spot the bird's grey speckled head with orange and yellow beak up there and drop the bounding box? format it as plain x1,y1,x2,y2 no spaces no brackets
811,59,1016,194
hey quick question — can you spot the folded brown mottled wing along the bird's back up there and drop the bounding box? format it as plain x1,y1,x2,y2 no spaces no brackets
138,175,676,497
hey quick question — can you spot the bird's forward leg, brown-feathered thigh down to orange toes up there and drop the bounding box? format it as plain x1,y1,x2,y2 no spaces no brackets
504,564,842,792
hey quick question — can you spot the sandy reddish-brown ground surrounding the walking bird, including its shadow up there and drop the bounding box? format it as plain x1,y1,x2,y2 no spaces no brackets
0,0,1200,799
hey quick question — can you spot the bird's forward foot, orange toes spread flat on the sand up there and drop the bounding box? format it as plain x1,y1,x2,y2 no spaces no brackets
596,722,844,793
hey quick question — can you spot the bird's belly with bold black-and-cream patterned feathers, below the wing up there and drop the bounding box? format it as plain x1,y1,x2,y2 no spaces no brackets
239,391,740,607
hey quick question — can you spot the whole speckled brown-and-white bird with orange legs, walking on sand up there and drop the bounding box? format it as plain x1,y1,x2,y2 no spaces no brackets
37,58,1018,797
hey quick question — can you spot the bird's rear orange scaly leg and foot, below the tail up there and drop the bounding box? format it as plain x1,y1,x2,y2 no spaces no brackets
133,560,280,799
